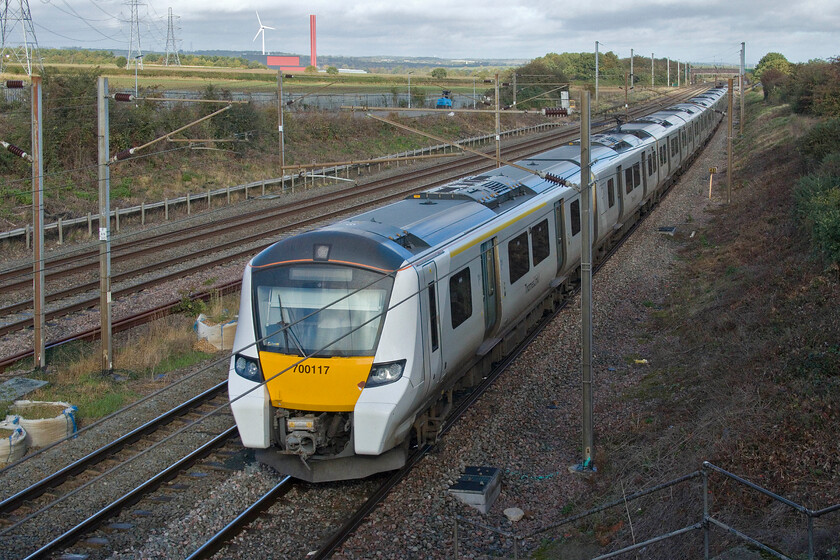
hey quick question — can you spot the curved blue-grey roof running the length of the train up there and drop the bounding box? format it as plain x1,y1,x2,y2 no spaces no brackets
253,86,722,270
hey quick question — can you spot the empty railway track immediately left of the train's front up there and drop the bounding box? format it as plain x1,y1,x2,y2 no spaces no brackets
0,374,236,559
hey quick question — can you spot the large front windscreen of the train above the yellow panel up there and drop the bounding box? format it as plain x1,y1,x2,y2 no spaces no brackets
252,264,393,356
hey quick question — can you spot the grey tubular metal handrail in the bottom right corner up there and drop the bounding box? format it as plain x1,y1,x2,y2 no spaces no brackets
453,461,840,560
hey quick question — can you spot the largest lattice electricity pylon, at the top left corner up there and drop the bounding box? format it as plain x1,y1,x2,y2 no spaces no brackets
0,0,44,76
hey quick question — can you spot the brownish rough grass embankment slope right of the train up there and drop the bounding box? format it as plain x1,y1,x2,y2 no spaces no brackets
539,91,840,558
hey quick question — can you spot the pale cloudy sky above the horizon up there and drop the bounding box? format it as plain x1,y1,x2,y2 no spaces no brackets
16,0,840,66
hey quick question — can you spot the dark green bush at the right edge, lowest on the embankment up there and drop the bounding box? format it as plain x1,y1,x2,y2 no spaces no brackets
795,174,840,263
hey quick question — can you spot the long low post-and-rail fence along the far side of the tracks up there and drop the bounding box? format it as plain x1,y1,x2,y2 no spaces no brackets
0,122,559,247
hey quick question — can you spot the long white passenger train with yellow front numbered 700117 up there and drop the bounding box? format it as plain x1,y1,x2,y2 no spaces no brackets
228,88,726,482
